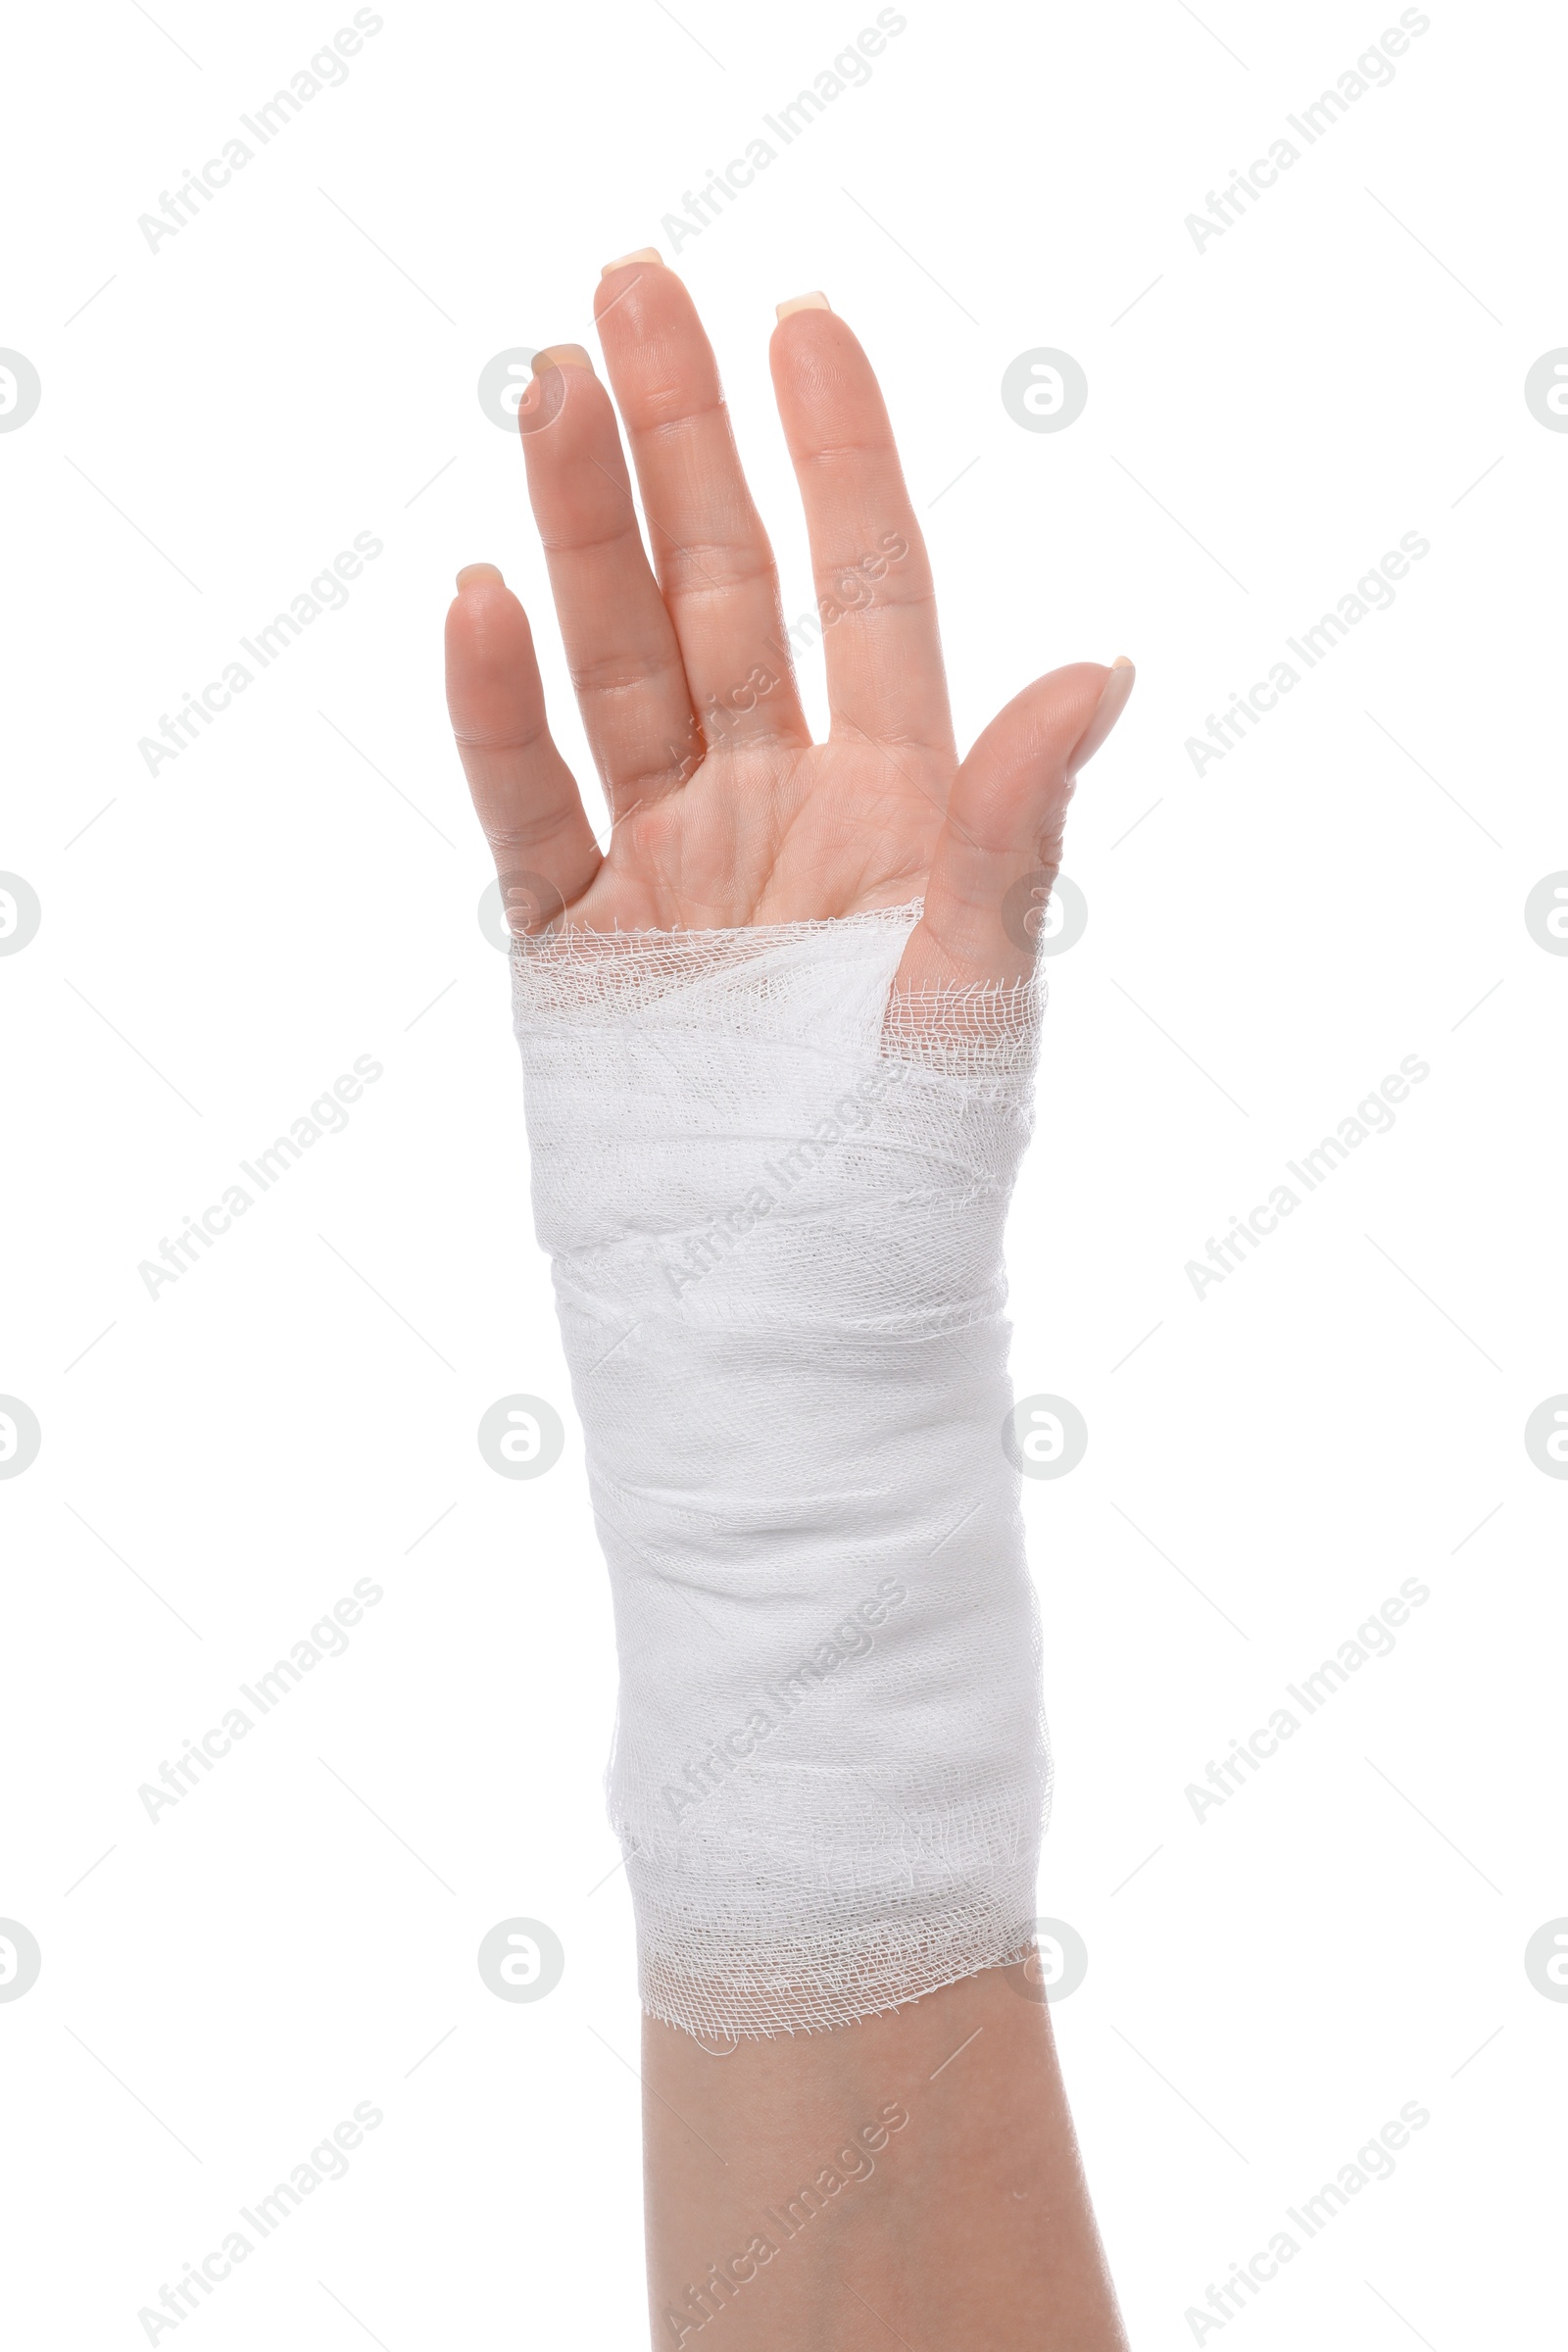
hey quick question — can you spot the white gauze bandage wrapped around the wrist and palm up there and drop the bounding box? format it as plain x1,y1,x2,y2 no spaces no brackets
513,906,1051,2036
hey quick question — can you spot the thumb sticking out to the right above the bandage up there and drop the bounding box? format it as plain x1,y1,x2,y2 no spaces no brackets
898,657,1136,990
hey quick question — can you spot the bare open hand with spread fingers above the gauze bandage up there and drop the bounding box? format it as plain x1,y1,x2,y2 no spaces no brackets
447,254,1133,988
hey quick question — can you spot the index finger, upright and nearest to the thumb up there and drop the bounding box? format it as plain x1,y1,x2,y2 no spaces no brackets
768,294,955,755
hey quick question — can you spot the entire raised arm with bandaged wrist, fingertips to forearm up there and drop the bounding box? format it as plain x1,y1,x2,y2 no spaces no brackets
449,257,1131,2352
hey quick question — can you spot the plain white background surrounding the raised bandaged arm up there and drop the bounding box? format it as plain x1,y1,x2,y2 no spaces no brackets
0,0,1568,2352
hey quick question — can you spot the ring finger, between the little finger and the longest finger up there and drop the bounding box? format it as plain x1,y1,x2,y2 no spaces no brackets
517,343,703,818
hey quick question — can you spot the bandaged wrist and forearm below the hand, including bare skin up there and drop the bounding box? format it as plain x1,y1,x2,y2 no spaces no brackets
517,912,1121,2352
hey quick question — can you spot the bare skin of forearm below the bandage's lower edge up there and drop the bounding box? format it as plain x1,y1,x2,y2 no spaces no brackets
642,1966,1126,2352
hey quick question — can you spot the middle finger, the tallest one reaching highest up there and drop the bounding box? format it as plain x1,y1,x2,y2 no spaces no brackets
595,259,811,748
